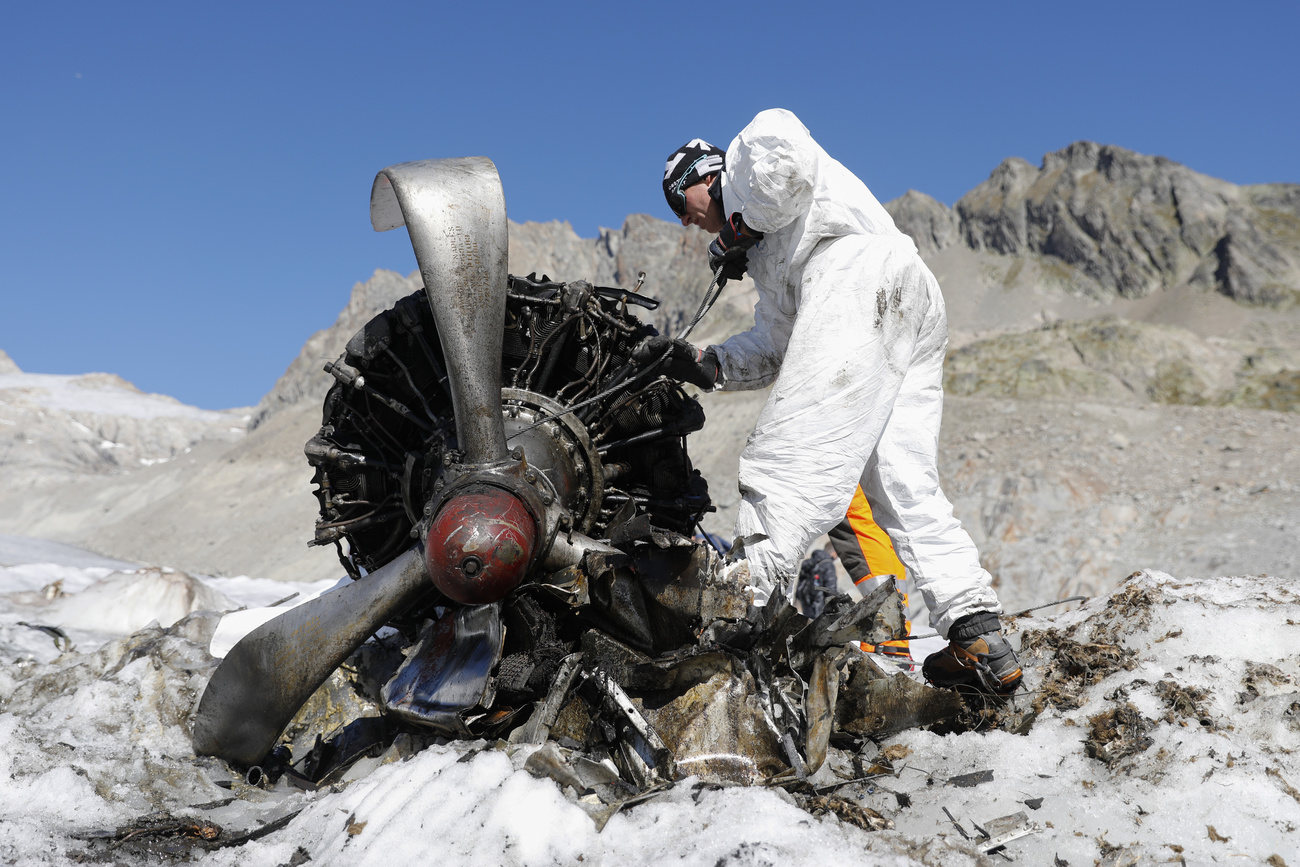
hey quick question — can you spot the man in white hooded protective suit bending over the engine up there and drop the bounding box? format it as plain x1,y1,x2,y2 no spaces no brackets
637,109,1022,694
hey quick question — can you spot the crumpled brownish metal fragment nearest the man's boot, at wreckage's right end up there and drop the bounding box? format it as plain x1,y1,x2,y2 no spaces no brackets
835,647,962,737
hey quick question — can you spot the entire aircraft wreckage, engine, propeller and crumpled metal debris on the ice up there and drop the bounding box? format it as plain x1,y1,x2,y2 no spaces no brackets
194,157,961,803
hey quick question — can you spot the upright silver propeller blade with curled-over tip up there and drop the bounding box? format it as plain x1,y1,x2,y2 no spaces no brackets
371,156,507,464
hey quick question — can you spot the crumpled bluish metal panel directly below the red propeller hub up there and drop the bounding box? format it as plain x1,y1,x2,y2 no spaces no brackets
382,603,506,737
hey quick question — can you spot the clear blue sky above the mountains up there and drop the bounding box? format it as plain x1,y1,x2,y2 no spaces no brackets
0,0,1300,408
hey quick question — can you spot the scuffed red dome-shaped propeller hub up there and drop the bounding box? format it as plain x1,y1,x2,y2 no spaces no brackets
424,487,537,604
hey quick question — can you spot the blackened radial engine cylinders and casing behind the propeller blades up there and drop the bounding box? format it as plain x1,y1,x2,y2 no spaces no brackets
308,278,709,577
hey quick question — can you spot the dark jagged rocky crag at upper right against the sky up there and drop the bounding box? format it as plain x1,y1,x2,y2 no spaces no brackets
956,142,1300,305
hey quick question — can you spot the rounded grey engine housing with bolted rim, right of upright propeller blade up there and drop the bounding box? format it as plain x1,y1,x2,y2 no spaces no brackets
501,389,605,533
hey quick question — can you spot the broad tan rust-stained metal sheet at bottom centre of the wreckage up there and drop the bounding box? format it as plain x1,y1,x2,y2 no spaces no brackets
638,654,787,785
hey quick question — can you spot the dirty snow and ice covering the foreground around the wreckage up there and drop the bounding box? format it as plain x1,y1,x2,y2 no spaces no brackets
0,537,1300,867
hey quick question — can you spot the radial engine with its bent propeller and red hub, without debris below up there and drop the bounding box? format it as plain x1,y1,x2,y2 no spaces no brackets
194,157,711,767
